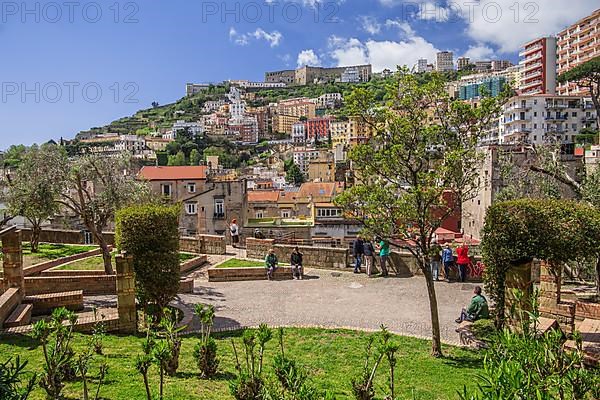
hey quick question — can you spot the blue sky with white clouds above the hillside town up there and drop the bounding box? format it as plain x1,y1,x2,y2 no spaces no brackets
0,0,596,149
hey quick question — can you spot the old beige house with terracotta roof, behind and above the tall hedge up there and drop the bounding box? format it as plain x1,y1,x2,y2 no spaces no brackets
138,166,246,235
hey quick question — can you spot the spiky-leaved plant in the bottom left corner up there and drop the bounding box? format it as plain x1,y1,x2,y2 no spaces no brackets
0,356,36,400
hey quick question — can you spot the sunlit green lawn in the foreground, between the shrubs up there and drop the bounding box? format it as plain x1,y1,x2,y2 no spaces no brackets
0,328,482,400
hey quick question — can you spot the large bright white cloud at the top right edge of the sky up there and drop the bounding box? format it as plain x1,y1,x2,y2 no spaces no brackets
458,0,598,53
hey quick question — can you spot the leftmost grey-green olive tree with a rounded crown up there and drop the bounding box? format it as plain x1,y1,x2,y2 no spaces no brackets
6,144,66,253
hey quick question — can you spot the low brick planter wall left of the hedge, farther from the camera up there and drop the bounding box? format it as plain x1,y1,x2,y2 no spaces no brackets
25,275,116,296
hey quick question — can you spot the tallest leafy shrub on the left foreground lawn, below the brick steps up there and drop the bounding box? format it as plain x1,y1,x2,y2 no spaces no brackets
32,308,77,399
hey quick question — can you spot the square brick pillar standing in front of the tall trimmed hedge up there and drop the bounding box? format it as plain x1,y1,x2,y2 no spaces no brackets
115,254,137,333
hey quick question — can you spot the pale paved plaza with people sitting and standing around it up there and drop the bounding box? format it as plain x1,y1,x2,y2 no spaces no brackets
90,250,474,344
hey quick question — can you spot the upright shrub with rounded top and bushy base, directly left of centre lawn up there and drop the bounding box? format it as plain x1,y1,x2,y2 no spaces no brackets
194,304,219,378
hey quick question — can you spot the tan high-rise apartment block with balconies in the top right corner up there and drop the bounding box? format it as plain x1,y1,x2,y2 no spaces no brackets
557,9,600,96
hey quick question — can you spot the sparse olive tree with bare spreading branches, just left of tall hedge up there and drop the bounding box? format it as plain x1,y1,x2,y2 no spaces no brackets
59,155,151,274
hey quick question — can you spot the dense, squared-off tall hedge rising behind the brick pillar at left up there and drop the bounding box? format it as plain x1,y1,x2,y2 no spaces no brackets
115,204,180,308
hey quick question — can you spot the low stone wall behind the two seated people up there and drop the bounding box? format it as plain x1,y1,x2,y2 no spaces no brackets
246,238,349,269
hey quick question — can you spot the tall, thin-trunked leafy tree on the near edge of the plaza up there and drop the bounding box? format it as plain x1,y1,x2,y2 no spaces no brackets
335,70,502,356
